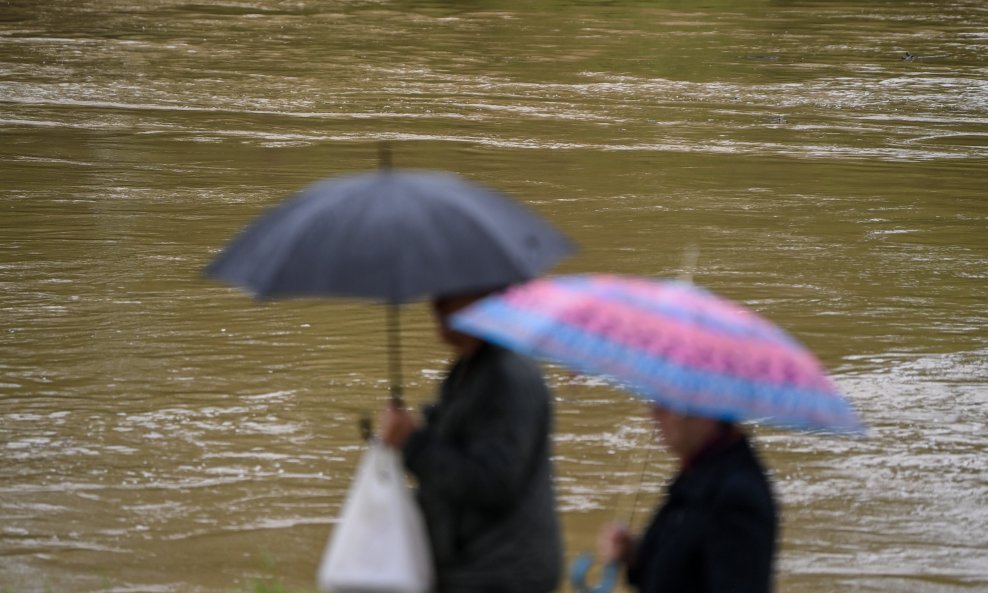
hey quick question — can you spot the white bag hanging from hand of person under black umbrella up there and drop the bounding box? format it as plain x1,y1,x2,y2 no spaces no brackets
316,441,434,593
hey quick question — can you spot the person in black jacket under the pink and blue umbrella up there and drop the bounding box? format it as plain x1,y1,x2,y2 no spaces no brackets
601,406,778,593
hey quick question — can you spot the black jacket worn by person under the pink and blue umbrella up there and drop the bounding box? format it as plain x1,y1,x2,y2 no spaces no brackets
628,437,777,593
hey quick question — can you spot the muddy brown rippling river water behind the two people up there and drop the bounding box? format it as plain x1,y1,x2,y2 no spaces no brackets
0,0,988,593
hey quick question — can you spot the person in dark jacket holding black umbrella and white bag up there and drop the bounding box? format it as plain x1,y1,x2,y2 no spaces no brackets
380,295,562,593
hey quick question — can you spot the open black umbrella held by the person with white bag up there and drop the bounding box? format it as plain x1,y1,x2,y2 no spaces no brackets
205,157,574,408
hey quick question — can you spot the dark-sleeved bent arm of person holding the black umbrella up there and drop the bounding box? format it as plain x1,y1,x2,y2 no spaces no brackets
403,364,548,508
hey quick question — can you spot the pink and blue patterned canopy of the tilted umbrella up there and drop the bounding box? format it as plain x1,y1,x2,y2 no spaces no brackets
452,275,862,432
